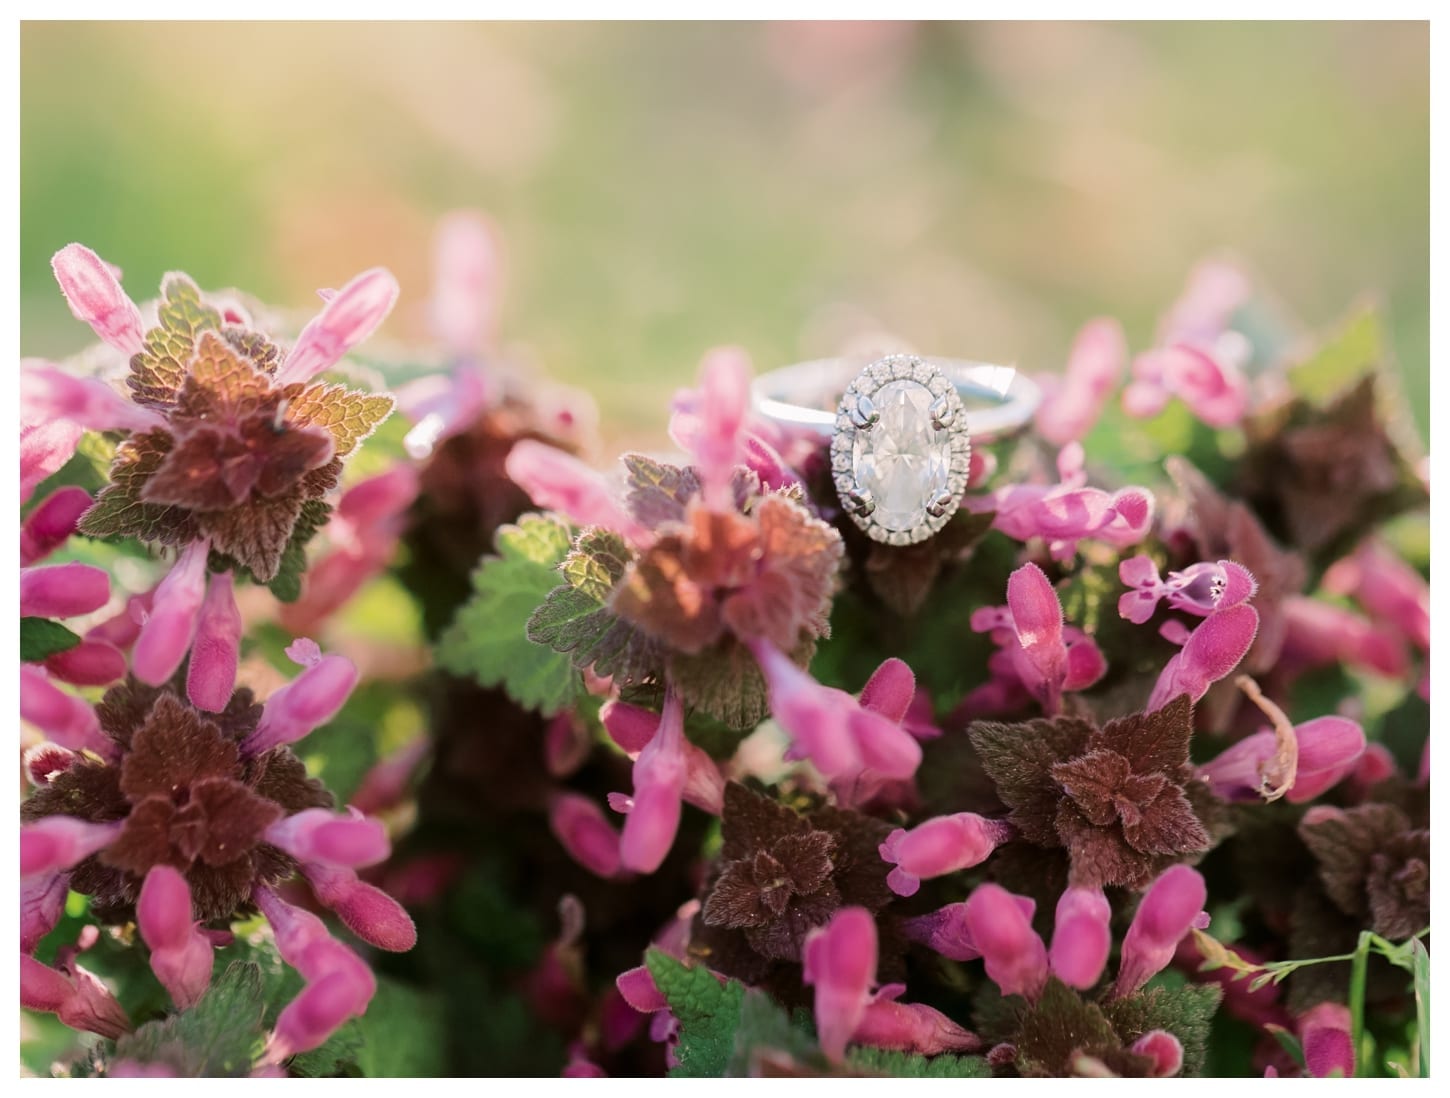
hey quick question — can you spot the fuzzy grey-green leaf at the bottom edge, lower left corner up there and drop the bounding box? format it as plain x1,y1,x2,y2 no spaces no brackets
115,962,265,1078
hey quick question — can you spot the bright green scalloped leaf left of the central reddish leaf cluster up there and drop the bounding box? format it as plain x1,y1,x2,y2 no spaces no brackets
438,515,580,715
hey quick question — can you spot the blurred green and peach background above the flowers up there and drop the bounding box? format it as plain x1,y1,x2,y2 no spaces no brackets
20,23,1430,438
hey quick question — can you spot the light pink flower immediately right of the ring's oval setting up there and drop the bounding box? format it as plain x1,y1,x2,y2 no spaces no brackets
961,442,1153,560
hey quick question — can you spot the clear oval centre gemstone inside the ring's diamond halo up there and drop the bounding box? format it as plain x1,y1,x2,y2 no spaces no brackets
851,380,951,531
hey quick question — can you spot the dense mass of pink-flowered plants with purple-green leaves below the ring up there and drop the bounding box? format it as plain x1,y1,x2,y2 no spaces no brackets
20,215,1430,1078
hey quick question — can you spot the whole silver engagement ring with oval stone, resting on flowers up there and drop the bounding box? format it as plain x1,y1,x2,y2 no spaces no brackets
751,354,1041,545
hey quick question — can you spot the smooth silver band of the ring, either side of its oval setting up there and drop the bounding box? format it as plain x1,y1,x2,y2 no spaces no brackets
751,355,1043,442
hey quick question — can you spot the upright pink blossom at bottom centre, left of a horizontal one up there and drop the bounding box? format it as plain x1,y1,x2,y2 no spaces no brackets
800,908,877,1063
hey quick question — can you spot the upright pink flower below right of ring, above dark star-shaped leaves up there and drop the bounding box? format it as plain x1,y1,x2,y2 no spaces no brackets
969,563,1108,714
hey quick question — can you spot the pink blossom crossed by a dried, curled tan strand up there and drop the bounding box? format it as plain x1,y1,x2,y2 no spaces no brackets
1199,717,1364,805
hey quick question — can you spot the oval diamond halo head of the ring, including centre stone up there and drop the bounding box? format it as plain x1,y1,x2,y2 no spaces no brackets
831,354,972,545
